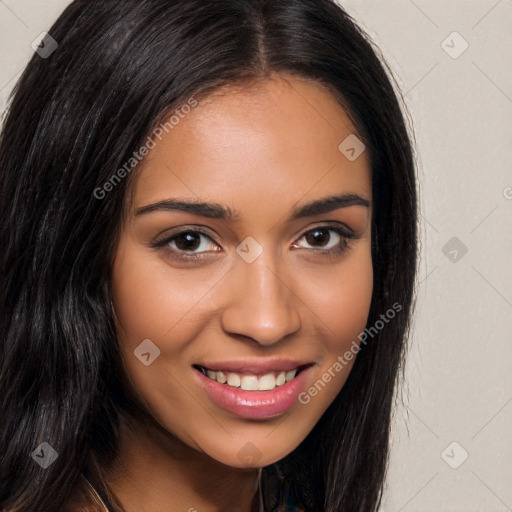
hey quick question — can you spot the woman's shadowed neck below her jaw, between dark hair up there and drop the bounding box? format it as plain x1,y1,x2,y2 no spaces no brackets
106,412,261,512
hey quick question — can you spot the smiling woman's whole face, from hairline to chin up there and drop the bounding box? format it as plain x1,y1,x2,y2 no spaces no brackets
112,75,373,467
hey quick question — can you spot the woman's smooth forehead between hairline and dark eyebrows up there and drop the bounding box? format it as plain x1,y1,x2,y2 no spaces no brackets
133,75,371,220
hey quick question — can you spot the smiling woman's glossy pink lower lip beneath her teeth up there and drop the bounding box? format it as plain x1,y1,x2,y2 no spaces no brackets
194,367,310,419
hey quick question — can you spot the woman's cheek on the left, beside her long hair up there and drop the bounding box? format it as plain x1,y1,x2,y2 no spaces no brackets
112,235,211,400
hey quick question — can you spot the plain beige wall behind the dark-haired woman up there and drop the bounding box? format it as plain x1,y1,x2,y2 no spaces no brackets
0,0,512,512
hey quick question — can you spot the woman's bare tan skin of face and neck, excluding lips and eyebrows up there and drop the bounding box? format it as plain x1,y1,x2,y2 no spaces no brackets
109,74,373,512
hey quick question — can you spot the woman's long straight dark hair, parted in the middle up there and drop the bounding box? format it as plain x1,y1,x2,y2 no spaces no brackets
0,0,417,512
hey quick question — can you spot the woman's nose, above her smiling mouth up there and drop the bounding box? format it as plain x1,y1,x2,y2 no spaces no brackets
222,251,301,346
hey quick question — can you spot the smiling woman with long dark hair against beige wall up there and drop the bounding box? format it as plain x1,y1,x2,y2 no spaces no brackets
0,0,417,512
